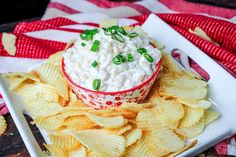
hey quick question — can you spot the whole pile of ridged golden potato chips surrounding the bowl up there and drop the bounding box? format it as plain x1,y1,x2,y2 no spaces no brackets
0,47,219,157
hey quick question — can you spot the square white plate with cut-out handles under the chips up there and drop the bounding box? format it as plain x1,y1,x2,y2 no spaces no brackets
0,14,236,157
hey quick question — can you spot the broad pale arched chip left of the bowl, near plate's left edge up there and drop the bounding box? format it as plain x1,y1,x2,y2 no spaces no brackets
17,83,59,102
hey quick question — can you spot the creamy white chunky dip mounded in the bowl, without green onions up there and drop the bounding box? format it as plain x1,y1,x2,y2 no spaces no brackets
63,26,161,92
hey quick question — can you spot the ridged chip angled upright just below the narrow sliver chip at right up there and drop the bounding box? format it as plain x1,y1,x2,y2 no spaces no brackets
179,106,204,128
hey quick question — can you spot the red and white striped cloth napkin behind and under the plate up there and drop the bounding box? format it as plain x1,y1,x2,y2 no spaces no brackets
0,0,236,155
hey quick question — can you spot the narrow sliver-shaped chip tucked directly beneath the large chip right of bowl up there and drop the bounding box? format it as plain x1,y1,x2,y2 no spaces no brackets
177,98,211,109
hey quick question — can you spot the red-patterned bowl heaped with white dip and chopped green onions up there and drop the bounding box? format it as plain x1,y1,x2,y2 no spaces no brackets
62,26,161,109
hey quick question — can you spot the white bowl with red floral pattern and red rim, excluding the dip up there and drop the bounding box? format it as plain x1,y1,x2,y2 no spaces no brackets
61,58,161,109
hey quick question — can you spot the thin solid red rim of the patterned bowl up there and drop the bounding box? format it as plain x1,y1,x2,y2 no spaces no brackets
61,57,161,95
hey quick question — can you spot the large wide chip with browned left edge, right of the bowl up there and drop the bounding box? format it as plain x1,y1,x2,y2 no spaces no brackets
159,72,207,100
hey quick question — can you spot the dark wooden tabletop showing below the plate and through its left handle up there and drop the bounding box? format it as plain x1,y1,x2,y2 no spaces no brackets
0,114,232,157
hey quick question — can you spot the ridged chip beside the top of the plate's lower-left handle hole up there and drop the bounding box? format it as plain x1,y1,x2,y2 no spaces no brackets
33,114,64,131
